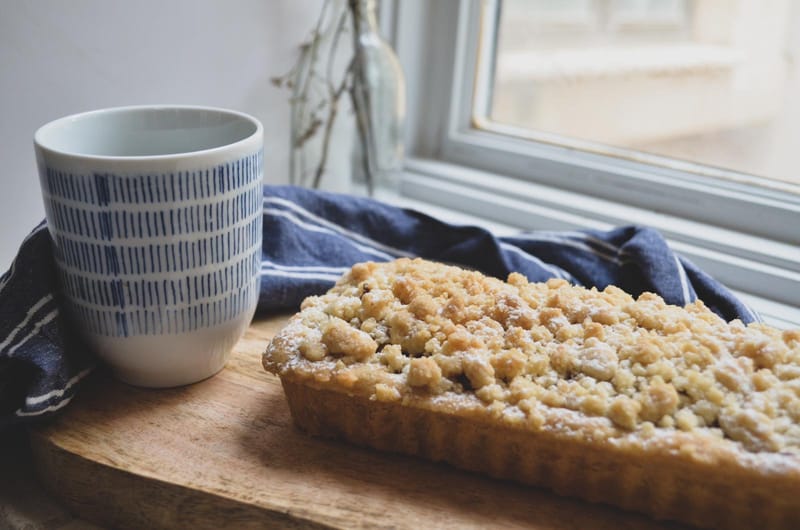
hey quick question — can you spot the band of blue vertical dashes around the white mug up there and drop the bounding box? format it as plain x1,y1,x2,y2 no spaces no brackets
43,152,263,337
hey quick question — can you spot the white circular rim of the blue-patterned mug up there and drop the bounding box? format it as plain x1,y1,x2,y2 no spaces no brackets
33,104,264,162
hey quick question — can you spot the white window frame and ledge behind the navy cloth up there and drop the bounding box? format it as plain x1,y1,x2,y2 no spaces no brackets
382,0,800,325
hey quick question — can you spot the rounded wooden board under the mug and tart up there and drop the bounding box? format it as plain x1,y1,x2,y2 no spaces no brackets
30,316,677,530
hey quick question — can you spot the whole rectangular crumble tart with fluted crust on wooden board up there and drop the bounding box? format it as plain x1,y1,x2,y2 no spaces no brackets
263,259,800,528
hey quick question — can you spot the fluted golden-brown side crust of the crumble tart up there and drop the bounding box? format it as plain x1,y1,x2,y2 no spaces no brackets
283,380,800,530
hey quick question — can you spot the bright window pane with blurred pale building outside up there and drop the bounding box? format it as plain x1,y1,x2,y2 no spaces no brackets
484,0,800,188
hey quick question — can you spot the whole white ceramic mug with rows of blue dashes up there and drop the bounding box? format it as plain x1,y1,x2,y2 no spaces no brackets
34,106,263,387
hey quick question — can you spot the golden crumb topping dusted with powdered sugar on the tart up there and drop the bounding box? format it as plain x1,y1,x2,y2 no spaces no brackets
266,258,800,454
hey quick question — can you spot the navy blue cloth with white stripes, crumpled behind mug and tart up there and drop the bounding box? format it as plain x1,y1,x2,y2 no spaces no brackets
0,186,757,427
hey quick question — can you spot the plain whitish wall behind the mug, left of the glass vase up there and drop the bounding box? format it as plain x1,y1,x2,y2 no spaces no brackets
0,0,321,273
